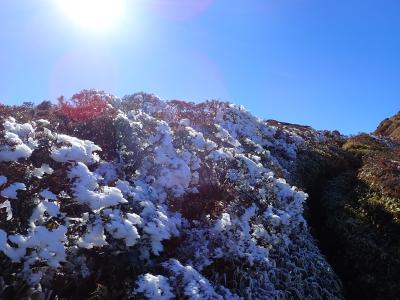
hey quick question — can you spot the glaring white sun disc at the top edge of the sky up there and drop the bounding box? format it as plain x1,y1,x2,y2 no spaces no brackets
58,0,125,32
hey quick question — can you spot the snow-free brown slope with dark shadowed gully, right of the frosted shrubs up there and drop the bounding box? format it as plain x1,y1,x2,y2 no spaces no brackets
282,123,400,299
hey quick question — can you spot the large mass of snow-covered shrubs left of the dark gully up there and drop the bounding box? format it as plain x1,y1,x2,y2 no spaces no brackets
0,92,341,299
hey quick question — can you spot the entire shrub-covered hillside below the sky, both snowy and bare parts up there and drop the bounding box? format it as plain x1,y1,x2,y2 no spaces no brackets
0,90,400,299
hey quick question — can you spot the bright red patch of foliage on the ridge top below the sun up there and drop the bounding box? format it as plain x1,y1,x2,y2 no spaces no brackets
58,90,111,121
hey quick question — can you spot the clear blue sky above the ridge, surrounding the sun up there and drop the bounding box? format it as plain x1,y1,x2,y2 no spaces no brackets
0,0,400,134
